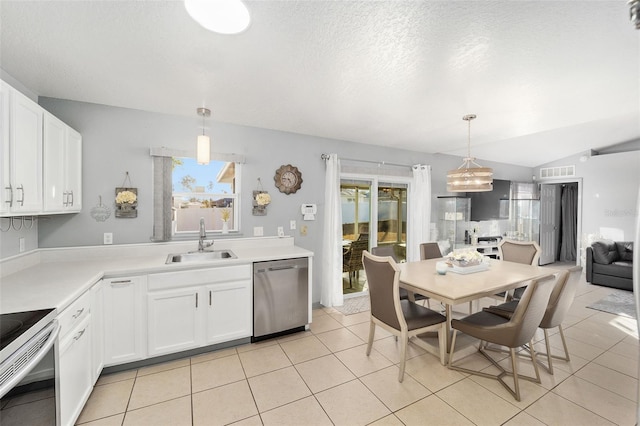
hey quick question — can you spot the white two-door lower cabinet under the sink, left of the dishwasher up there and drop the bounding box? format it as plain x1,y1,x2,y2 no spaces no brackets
147,265,253,356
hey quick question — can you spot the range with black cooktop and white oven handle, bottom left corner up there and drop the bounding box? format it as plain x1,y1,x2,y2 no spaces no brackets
0,309,60,426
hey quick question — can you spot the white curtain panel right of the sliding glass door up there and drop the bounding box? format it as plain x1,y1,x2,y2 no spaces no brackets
407,164,431,262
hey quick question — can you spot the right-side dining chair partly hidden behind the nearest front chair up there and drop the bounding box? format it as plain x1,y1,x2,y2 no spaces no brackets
484,266,582,374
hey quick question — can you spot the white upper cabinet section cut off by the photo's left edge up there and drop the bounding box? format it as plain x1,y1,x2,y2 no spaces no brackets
0,83,44,215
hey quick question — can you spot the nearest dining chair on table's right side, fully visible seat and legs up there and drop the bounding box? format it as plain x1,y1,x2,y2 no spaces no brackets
448,274,558,401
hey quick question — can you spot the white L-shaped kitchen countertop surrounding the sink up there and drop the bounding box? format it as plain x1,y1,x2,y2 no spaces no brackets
0,237,313,313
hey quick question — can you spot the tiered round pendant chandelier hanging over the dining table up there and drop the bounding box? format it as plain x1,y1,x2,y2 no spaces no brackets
447,114,493,192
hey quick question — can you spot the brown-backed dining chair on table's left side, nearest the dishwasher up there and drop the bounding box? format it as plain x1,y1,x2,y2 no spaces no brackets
362,251,446,382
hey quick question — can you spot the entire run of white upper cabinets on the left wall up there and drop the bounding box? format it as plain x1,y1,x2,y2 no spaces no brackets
0,80,82,217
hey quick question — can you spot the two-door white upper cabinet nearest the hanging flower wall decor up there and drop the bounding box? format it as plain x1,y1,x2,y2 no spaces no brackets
43,112,82,213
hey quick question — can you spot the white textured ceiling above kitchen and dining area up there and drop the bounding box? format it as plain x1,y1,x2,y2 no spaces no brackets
0,0,640,167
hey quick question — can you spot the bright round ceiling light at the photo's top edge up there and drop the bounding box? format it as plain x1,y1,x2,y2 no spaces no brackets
184,0,251,34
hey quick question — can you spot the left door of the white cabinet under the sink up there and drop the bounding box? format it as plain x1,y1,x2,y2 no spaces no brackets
147,287,203,355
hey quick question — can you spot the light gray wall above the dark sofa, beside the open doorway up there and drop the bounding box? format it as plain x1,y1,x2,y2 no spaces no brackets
535,150,640,241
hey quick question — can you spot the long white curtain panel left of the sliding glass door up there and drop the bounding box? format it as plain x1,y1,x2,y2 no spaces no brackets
320,154,343,307
